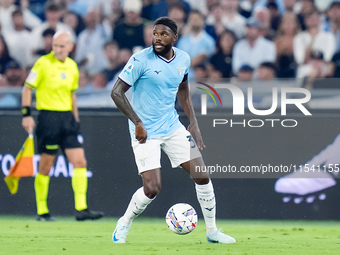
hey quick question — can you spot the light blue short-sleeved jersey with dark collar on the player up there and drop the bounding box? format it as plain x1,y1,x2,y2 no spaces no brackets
119,47,190,139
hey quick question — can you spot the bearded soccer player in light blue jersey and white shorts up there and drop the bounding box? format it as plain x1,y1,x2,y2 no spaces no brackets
111,17,235,243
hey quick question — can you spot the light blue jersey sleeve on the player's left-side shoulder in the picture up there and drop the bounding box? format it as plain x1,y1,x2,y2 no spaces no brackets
118,54,143,86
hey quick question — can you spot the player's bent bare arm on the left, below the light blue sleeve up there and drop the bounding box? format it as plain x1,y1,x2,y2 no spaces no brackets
111,78,147,143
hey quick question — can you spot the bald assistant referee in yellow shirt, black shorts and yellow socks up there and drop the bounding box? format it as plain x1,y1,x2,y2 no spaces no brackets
22,31,103,221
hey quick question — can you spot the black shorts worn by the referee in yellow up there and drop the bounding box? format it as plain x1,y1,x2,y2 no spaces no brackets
36,111,82,155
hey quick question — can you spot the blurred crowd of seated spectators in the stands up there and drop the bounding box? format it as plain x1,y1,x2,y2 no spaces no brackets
0,0,340,96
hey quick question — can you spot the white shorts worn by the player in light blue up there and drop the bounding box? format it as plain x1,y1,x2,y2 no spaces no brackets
131,126,202,173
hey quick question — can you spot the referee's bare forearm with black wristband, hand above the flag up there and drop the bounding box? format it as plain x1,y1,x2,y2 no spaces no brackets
21,85,35,134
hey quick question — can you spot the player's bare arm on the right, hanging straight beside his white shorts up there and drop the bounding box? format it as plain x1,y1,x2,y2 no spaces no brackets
177,80,205,150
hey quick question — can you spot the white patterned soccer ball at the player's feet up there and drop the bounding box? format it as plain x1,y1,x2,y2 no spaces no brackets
165,203,197,235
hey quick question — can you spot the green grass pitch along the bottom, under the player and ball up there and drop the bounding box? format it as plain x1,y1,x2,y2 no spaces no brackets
0,216,340,255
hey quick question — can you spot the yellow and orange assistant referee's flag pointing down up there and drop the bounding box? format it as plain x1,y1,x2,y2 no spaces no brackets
5,134,34,195
